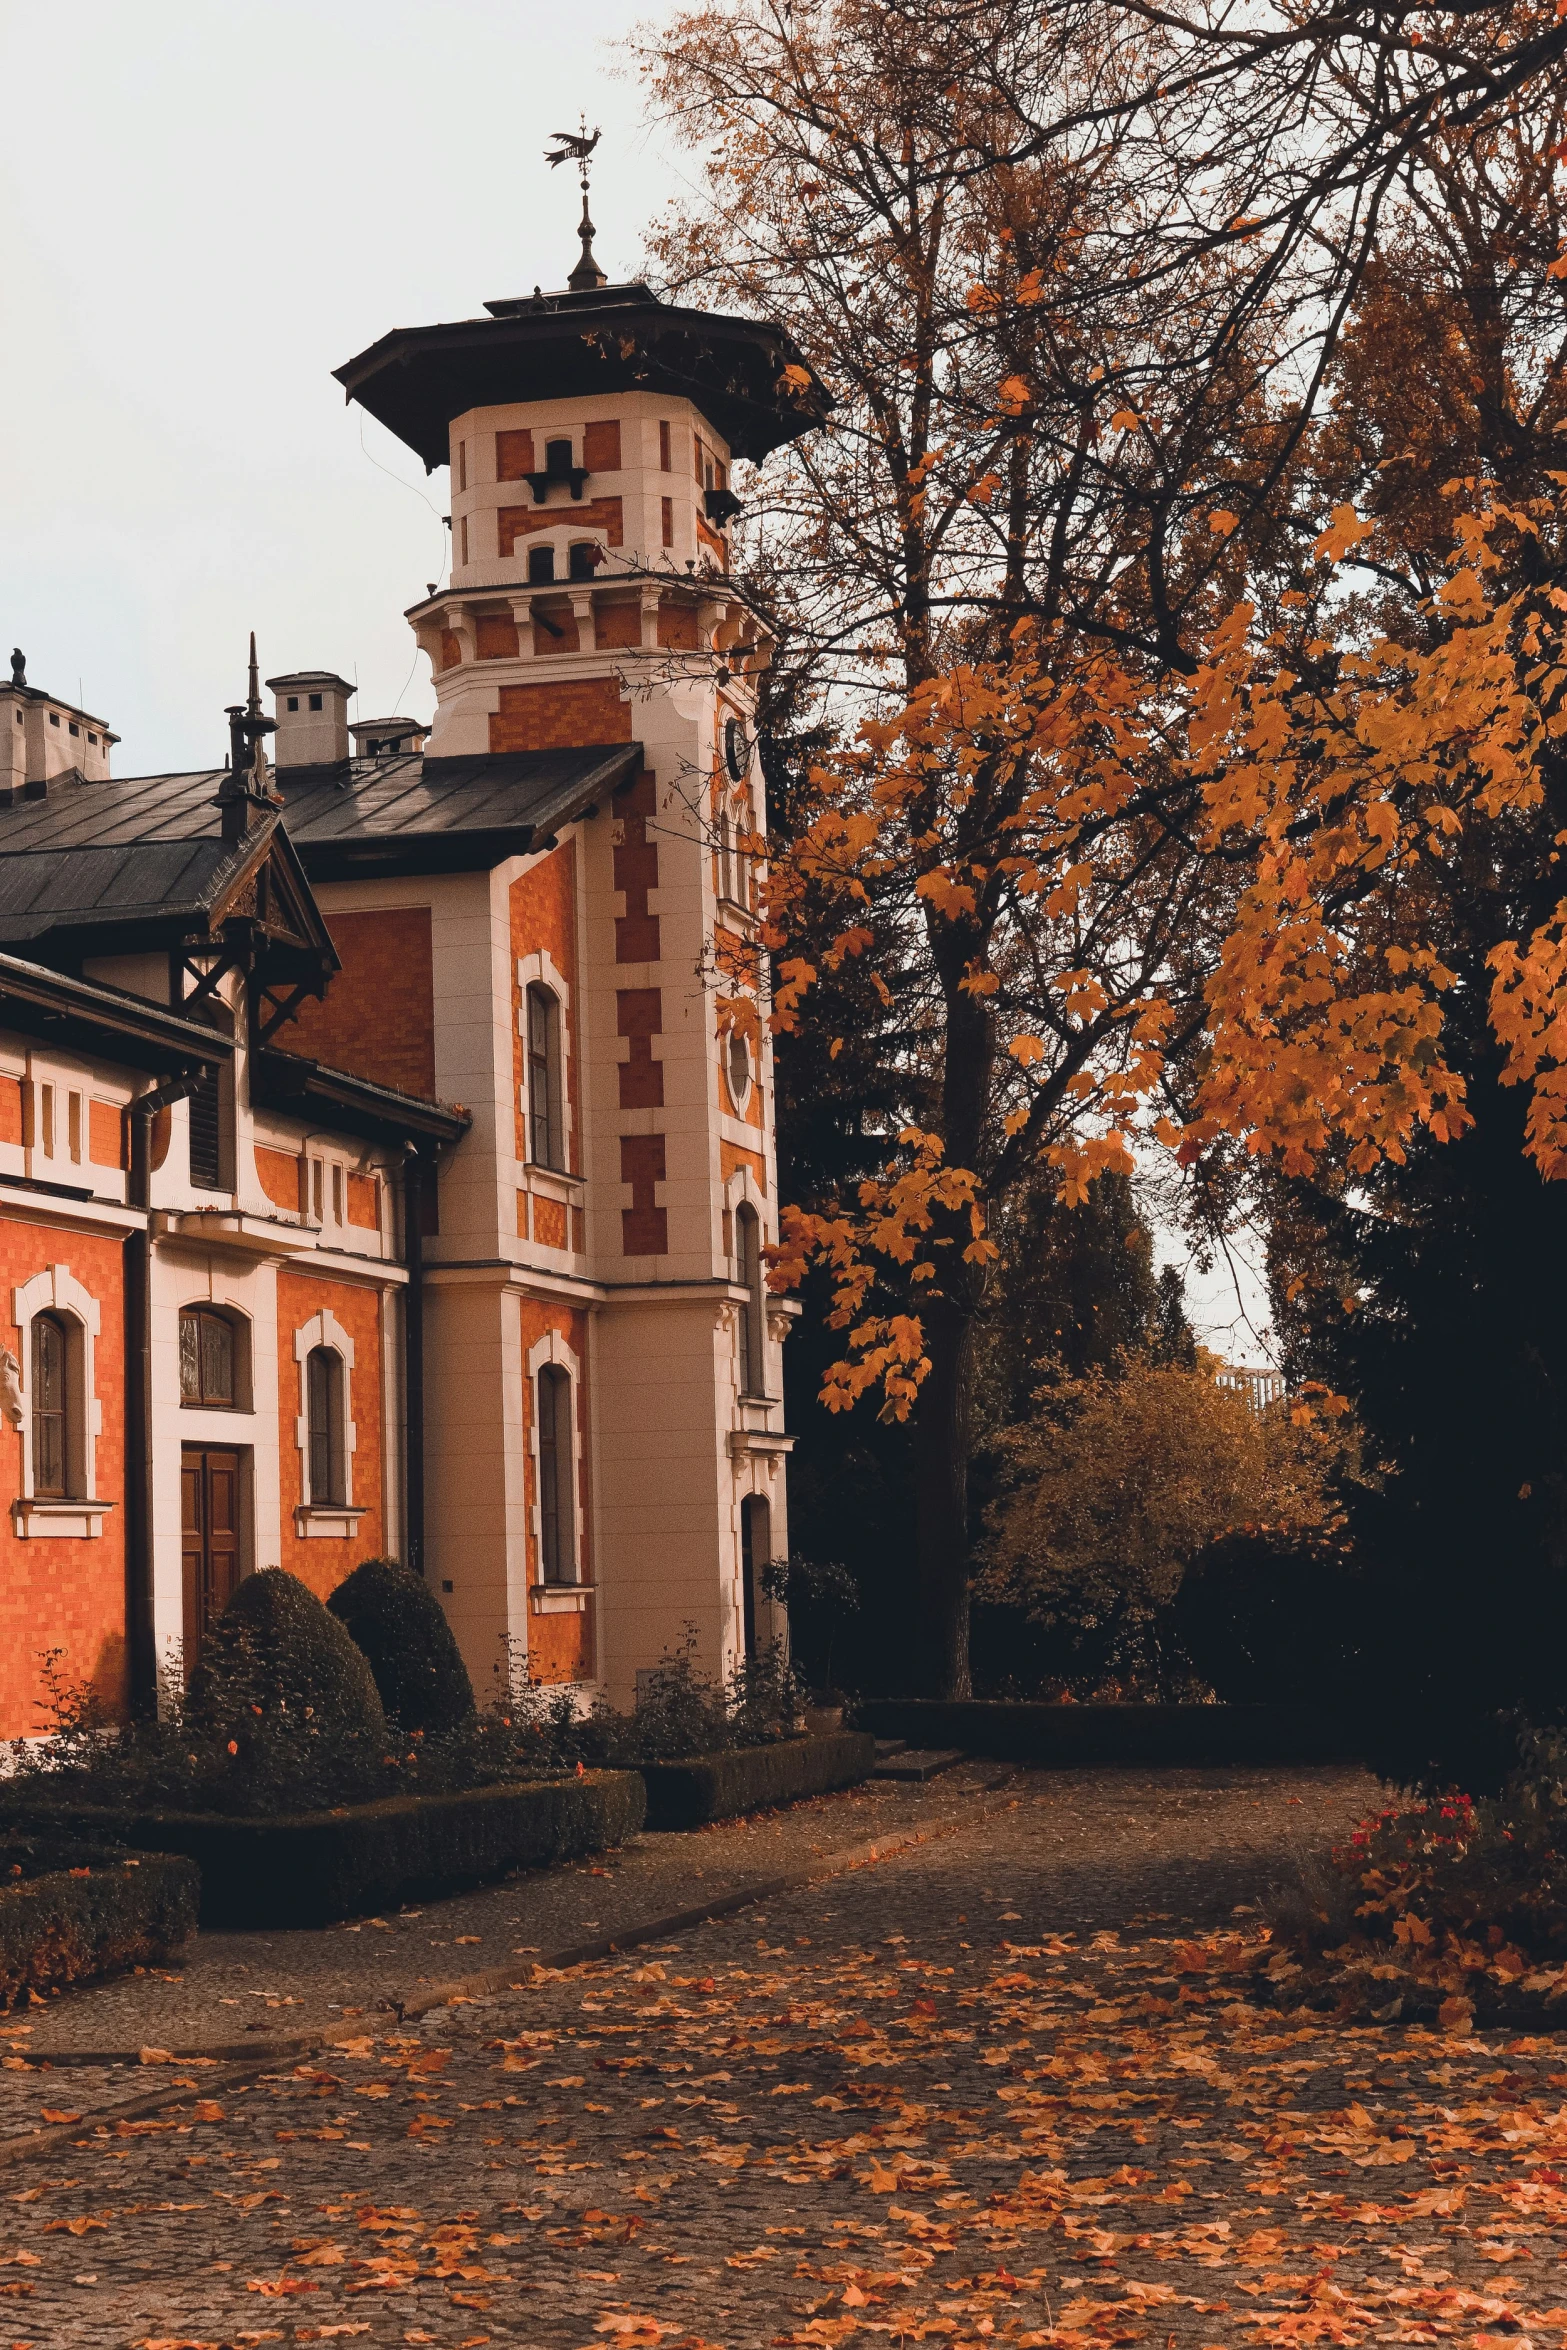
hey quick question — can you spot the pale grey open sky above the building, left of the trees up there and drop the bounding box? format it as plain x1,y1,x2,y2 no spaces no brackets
0,0,674,776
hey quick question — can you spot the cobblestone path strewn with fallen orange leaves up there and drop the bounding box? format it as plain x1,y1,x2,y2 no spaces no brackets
12,1772,1567,2350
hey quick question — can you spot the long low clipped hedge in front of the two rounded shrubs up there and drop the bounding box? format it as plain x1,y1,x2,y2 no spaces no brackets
0,1772,646,1927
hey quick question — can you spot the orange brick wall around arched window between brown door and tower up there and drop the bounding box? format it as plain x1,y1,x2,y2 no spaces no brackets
277,1271,385,1600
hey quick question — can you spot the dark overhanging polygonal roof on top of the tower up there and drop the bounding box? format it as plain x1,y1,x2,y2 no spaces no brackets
334,284,832,472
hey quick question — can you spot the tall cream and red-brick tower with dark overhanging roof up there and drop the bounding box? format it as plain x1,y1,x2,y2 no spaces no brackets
322,214,827,1699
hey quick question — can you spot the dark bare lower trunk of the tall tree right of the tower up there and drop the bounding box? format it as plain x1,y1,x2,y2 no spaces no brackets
909,1297,975,1697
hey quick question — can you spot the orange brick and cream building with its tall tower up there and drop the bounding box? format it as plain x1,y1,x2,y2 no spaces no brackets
0,229,825,1734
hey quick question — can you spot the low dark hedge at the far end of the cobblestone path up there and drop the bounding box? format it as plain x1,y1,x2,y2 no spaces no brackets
855,1697,1356,1770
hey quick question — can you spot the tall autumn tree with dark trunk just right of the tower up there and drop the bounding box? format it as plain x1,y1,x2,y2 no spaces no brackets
644,0,1562,1690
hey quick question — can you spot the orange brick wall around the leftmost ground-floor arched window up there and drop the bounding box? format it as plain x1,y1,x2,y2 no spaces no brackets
0,1217,127,1739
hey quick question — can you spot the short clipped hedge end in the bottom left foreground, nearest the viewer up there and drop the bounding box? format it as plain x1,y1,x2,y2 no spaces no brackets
0,1835,200,2009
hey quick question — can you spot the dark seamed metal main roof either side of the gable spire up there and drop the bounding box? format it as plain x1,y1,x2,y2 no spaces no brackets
0,743,644,883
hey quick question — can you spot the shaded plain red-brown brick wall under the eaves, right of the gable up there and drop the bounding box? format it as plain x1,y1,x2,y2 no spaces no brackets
277,905,435,1100
